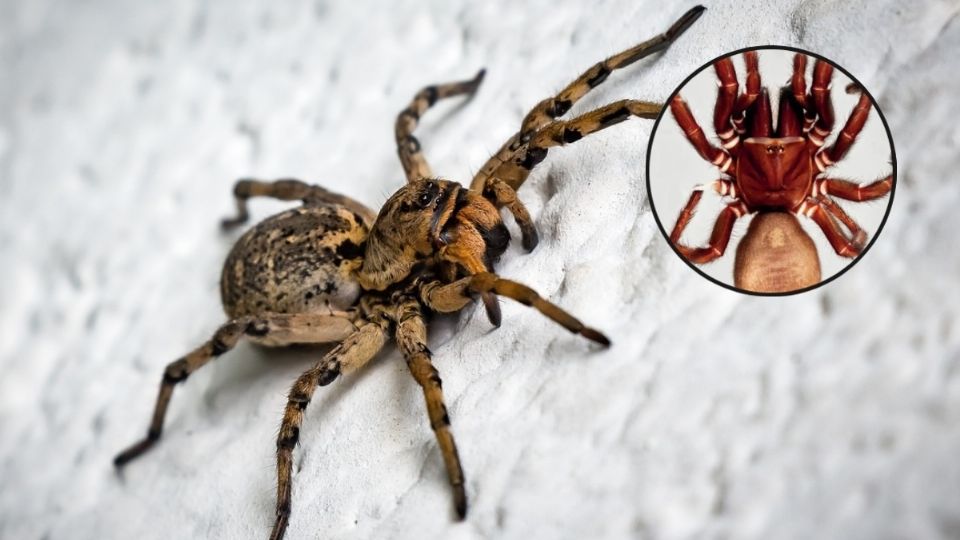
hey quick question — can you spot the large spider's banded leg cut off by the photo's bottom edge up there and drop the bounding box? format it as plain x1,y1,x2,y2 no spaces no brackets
270,318,388,540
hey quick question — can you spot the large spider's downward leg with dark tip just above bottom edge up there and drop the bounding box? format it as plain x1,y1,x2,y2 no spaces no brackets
396,301,467,519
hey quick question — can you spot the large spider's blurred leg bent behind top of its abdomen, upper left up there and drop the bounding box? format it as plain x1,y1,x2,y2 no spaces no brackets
220,178,377,229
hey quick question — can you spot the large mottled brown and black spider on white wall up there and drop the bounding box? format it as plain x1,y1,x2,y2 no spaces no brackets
114,7,704,539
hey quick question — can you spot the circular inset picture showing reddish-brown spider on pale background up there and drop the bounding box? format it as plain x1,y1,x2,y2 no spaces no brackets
647,47,896,295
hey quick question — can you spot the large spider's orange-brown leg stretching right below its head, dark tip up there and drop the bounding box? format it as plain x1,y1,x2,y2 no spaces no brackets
420,272,610,347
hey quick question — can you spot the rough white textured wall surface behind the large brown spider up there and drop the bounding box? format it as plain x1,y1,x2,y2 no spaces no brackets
0,0,960,539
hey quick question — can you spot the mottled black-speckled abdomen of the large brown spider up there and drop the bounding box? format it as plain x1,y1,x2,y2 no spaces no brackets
220,205,368,317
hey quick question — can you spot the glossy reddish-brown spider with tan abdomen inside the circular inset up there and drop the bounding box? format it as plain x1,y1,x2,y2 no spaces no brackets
669,51,893,292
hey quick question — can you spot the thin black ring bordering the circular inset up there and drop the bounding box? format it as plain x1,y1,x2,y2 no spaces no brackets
645,45,899,297
